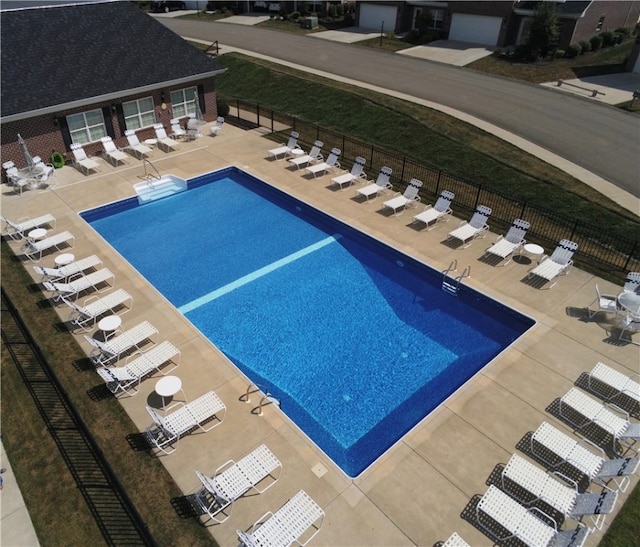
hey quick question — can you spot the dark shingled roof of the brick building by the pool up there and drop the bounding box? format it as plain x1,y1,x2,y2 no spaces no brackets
0,1,224,118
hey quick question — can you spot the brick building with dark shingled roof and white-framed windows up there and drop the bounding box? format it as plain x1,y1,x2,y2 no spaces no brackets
0,1,225,173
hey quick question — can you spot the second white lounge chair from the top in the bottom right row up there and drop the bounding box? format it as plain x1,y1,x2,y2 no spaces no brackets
559,387,640,454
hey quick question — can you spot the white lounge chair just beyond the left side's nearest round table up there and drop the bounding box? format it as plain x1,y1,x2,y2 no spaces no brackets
96,340,180,397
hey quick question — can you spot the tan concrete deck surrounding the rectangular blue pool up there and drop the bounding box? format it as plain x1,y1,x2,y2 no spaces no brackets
2,124,640,546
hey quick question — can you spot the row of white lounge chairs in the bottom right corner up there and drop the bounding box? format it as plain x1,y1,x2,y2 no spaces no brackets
443,363,640,547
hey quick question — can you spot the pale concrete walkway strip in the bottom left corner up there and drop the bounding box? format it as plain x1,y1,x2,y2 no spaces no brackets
0,441,40,547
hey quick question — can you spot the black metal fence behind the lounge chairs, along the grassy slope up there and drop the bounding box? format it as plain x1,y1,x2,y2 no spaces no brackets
222,99,640,272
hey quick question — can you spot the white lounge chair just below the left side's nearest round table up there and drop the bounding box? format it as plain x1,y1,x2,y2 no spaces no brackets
145,391,227,454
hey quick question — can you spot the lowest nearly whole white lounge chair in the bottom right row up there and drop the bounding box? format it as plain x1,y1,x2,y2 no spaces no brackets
476,485,591,547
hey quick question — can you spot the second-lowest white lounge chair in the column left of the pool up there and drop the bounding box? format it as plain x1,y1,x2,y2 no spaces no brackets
195,444,282,523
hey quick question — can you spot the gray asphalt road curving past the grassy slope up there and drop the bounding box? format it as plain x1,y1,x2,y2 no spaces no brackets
161,19,640,197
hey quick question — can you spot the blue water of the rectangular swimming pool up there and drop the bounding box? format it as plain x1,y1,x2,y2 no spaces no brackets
82,168,533,476
